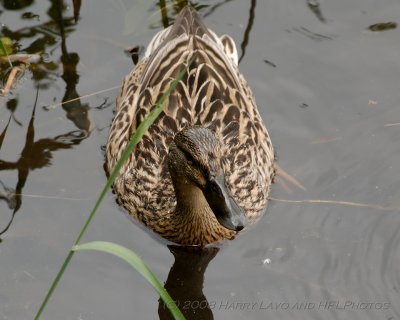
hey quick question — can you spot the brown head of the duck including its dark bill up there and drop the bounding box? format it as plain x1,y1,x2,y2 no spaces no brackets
168,127,246,231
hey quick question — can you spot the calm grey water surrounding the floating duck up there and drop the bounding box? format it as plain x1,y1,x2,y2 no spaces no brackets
0,0,400,319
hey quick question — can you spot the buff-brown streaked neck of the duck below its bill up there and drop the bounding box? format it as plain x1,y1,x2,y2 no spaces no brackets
170,180,235,245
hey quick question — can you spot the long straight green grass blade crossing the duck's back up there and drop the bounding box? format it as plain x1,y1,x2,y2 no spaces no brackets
35,60,193,320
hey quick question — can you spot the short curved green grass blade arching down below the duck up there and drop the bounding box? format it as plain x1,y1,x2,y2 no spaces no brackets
72,241,185,320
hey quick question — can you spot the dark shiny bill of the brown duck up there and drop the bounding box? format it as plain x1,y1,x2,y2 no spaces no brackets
203,175,247,231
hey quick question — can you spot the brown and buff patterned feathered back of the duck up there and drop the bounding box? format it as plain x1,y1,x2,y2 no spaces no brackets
106,7,274,231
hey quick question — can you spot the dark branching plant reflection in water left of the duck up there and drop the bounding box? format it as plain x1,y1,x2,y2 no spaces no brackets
0,0,90,235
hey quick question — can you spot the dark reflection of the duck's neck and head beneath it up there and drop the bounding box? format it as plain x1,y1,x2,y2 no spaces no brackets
158,245,219,320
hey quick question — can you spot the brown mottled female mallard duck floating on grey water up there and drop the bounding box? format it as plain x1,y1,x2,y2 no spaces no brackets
106,7,274,245
